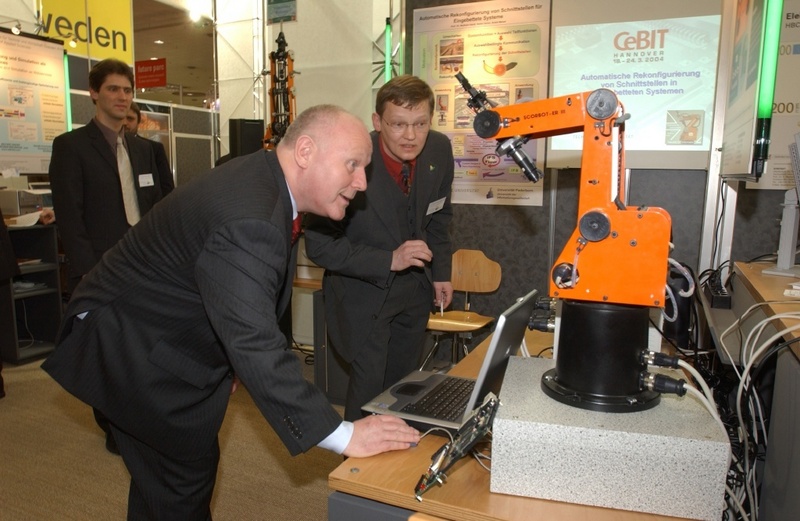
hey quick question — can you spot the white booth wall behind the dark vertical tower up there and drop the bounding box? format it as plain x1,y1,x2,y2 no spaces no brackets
216,0,400,155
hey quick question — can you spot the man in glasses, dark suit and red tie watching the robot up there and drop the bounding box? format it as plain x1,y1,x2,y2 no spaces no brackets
305,75,453,421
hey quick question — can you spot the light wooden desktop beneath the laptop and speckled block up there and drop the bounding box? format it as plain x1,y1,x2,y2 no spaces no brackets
328,332,692,521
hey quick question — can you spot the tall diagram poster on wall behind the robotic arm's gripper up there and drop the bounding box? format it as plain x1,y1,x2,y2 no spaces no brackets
413,0,550,206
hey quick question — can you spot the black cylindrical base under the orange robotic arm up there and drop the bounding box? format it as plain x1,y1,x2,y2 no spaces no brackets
542,300,660,412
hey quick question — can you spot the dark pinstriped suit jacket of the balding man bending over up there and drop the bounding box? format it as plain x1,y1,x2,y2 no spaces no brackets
43,151,342,458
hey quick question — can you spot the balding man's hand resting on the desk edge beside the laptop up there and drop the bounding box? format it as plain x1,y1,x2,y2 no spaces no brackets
343,414,420,458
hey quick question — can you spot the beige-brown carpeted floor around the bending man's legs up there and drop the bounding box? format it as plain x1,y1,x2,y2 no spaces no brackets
0,346,342,521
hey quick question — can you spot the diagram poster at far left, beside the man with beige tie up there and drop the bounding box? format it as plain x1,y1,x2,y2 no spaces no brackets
0,33,67,173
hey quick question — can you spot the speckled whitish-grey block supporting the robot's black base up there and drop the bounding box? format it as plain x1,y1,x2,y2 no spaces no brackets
491,357,730,521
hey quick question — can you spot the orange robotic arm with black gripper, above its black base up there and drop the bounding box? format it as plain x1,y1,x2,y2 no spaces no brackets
456,74,672,307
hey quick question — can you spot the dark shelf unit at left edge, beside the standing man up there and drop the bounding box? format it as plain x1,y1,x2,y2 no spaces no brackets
0,225,62,364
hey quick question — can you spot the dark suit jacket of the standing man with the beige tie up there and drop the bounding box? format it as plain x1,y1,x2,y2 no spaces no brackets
49,120,171,278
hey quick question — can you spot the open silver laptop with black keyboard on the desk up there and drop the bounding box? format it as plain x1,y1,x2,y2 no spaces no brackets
361,290,537,432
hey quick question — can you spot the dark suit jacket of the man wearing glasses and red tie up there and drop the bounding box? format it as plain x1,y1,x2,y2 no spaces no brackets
305,131,454,357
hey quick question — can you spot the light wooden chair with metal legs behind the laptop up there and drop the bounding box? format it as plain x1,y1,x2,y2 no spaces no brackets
420,250,502,369
